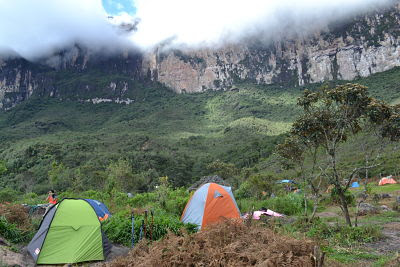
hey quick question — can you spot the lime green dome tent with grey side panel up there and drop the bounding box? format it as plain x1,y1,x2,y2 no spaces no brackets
28,199,111,264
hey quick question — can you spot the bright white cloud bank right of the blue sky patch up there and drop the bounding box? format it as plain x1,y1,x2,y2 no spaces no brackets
132,0,391,48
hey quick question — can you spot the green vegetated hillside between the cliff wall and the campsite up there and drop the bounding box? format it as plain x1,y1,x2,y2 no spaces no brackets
0,66,400,193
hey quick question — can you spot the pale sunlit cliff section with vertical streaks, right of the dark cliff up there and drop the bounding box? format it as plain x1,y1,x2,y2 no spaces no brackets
144,4,400,92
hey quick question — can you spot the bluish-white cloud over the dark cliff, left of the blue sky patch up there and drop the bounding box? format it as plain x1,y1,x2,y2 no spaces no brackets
0,0,128,59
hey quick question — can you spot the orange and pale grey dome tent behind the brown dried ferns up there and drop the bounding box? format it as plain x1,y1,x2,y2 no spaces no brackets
181,183,240,229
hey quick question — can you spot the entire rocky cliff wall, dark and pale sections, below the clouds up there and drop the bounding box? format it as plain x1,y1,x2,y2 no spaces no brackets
0,4,400,109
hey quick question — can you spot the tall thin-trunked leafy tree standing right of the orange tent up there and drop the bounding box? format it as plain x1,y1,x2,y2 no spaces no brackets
278,84,400,226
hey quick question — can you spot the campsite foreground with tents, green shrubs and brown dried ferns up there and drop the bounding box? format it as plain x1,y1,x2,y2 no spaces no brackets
0,176,400,266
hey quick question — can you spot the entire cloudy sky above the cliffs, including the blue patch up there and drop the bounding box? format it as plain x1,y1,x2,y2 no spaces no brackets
0,0,393,60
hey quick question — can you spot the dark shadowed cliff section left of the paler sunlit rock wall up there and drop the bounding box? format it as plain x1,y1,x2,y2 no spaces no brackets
0,47,145,109
